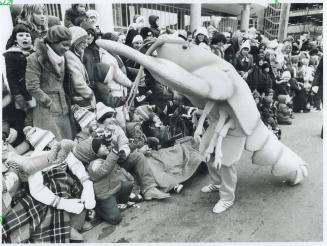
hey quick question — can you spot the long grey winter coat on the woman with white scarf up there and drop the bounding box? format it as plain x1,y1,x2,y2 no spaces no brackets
25,42,73,140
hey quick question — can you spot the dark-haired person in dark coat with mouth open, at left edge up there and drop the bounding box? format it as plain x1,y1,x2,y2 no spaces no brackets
3,24,35,142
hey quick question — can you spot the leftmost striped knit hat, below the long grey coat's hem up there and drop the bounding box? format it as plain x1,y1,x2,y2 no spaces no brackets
23,126,56,151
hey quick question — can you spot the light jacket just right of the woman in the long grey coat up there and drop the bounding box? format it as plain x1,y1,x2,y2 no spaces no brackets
65,50,95,110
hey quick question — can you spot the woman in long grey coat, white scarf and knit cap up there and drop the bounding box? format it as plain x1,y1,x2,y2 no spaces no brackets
26,25,73,140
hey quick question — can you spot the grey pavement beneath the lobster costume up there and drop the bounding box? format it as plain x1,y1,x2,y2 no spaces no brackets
83,112,323,243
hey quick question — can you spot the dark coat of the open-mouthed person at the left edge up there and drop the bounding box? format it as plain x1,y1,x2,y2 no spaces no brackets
3,47,32,109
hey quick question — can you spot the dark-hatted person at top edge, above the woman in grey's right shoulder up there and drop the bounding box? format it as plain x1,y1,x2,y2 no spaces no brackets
64,4,88,27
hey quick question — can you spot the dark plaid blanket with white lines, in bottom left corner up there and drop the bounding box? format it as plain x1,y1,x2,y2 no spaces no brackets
2,164,82,243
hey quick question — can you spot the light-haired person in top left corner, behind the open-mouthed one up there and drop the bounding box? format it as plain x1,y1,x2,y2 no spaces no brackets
17,4,61,45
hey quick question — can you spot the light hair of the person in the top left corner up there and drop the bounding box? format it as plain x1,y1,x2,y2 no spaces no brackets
18,4,48,30
